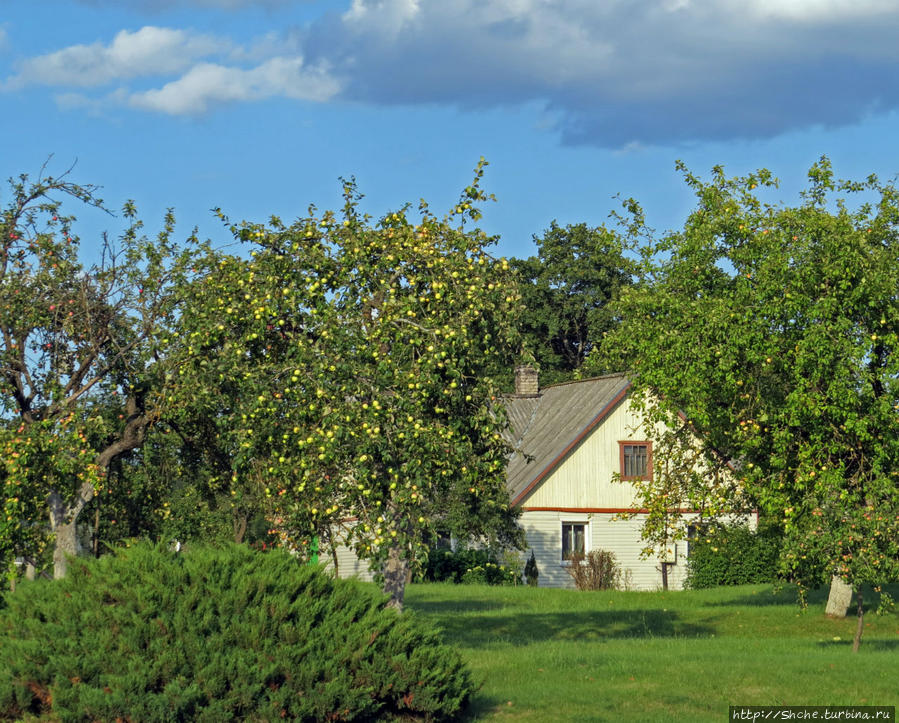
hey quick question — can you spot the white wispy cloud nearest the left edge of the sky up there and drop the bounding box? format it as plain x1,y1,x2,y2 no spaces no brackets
7,26,230,88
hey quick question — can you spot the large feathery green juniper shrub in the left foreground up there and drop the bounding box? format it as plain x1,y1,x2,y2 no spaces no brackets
0,545,473,722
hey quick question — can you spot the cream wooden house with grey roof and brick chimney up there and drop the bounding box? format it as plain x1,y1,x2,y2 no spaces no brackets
504,367,736,590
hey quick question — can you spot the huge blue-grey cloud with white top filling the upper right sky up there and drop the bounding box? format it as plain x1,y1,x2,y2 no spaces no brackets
304,0,899,148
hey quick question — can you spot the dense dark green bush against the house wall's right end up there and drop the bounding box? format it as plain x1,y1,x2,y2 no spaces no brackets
685,525,782,589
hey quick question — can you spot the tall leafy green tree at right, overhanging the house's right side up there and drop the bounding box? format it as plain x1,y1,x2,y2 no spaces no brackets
606,158,899,647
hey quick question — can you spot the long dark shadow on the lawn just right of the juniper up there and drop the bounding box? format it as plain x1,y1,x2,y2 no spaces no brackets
415,605,715,648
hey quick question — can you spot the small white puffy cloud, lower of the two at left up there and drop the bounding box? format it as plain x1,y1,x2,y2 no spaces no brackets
128,58,339,115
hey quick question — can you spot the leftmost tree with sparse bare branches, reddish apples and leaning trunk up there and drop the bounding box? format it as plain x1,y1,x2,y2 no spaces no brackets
0,165,206,577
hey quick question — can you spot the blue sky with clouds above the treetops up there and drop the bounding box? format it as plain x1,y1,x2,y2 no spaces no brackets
0,0,899,257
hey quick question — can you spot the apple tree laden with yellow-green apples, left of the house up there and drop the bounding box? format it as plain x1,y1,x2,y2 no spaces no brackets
182,161,519,607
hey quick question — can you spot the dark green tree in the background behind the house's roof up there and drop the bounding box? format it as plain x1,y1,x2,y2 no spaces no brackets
511,221,633,384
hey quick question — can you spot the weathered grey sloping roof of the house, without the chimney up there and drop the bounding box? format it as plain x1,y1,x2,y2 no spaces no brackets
503,374,630,505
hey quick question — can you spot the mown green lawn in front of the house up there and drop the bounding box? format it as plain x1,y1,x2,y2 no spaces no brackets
406,584,899,723
